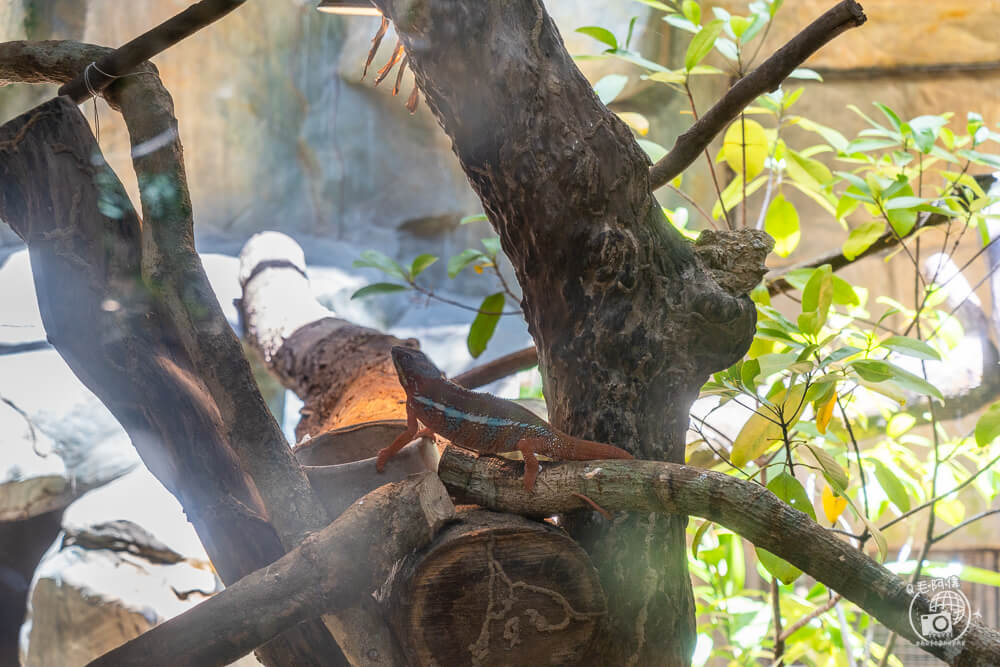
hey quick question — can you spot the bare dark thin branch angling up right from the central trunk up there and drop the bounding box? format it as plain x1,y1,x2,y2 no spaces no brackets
649,0,867,189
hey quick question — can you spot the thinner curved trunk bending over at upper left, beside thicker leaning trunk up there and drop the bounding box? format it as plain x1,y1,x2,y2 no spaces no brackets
0,42,328,549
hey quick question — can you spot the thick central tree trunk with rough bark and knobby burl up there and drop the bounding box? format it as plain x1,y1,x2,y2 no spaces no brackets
375,0,770,665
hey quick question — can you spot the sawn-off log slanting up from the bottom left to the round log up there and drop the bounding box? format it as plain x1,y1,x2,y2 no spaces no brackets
90,473,455,667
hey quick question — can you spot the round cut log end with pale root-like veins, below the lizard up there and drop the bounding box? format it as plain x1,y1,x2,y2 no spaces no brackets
383,509,606,666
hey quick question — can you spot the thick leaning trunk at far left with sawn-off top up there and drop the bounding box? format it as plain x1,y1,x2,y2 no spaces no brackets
0,92,346,665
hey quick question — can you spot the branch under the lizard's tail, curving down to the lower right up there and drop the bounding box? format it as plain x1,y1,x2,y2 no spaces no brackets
438,447,1000,665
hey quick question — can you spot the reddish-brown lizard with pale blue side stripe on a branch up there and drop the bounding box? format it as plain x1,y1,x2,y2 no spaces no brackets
375,346,633,491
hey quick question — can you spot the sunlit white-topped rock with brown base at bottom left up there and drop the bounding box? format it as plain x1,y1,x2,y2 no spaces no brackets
21,468,257,667
